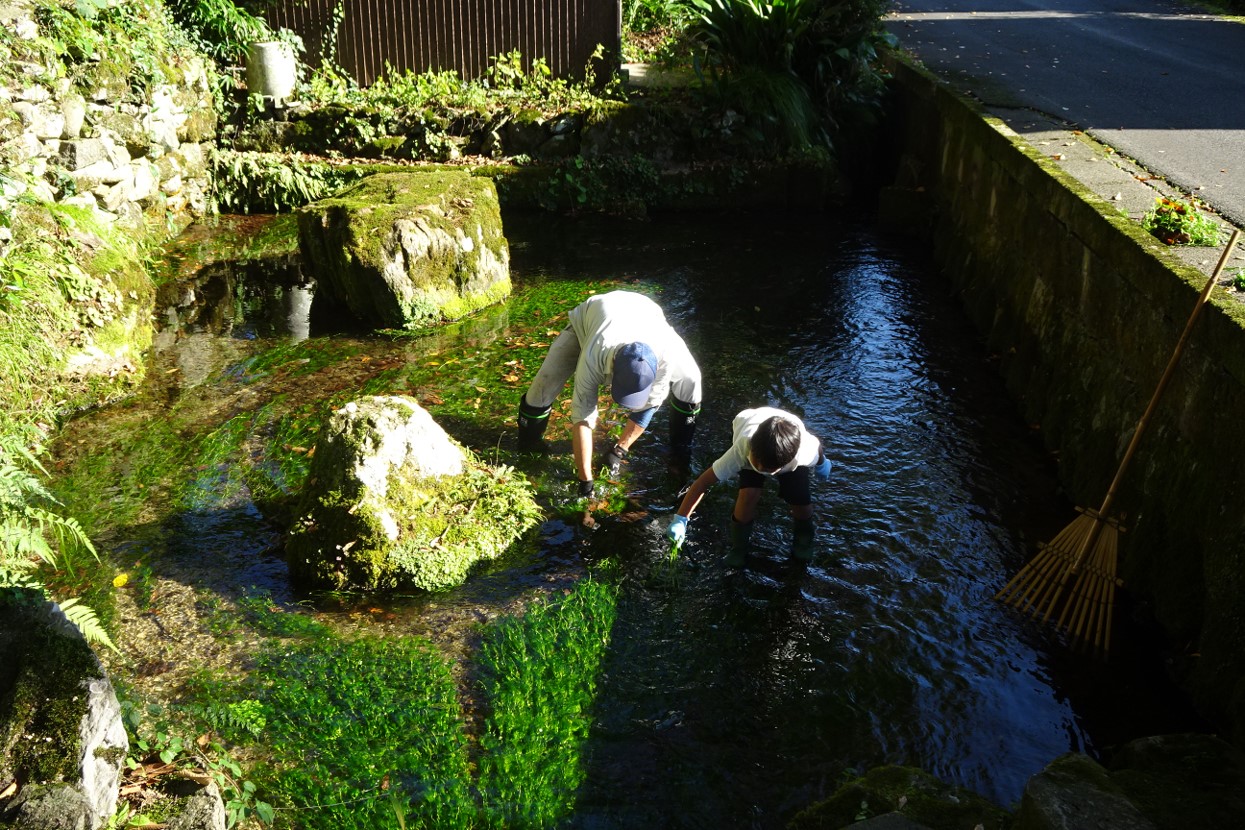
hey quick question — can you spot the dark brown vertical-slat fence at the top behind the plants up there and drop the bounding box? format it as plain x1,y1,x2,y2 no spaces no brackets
264,0,621,86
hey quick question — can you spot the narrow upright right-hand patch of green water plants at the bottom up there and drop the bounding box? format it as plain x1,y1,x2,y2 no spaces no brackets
479,579,618,828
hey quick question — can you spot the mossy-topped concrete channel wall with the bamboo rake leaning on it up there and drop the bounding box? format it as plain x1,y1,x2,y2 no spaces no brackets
880,60,1245,745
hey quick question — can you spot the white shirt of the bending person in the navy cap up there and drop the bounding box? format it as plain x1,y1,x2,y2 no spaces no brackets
568,291,701,429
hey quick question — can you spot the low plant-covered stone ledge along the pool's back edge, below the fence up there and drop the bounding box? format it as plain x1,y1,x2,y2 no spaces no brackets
214,91,849,217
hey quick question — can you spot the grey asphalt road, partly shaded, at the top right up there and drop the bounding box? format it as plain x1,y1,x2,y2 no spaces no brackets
886,0,1245,226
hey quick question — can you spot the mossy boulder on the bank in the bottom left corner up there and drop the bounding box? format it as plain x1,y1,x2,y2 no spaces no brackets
0,590,129,828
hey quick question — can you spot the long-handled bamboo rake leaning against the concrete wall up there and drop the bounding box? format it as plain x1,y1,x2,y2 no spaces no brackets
995,229,1240,656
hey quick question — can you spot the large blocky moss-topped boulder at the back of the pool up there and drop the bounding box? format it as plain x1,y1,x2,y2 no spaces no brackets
299,170,510,329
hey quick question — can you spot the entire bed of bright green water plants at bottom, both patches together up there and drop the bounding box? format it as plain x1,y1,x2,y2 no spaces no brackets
185,579,618,830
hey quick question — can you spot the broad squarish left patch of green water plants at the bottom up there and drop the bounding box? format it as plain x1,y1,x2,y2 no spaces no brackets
256,637,476,830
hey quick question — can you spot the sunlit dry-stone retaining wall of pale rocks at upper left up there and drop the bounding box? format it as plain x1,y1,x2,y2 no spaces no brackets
0,0,217,226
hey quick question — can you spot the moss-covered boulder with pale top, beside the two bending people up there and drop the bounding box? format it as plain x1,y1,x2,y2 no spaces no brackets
285,396,540,591
